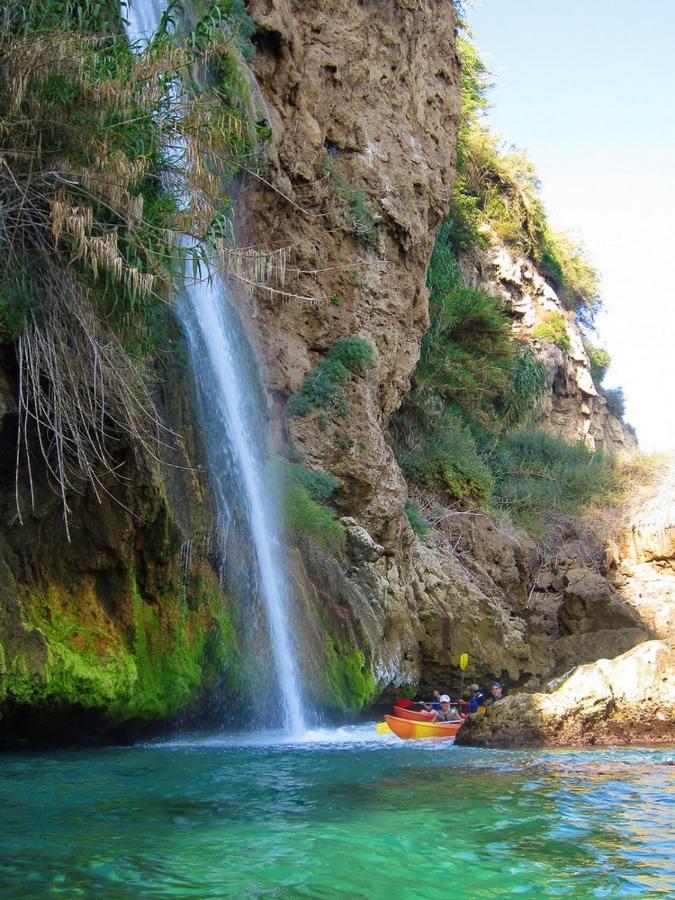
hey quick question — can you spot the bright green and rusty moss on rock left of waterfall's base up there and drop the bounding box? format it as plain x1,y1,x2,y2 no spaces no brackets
0,573,243,721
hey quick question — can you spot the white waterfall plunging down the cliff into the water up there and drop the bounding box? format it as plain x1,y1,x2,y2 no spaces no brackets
127,0,305,736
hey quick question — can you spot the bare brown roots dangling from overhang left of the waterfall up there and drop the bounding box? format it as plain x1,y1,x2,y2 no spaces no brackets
16,265,172,539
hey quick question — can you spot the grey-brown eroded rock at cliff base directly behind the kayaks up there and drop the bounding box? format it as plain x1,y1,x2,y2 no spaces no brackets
304,518,531,693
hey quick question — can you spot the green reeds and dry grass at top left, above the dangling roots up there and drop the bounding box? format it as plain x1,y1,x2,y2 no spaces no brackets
0,0,257,340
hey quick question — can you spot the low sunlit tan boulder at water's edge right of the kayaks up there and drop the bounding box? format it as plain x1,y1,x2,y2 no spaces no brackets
457,641,675,747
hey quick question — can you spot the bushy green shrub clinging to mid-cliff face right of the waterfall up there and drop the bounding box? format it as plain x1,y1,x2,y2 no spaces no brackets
286,337,375,417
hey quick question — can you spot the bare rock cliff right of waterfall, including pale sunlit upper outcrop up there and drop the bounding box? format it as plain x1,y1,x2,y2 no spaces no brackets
235,2,645,704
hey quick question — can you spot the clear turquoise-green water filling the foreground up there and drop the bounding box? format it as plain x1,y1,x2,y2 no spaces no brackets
0,727,675,900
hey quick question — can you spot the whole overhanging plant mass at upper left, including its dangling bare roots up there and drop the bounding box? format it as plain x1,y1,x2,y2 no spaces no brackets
0,0,258,521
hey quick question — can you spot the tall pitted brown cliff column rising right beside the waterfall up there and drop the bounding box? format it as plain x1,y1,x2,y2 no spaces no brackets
244,0,459,552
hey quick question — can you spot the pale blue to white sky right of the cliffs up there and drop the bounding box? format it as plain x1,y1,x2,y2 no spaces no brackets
465,0,675,451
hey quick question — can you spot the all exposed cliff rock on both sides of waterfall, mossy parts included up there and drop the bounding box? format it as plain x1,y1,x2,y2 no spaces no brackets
0,0,663,739
